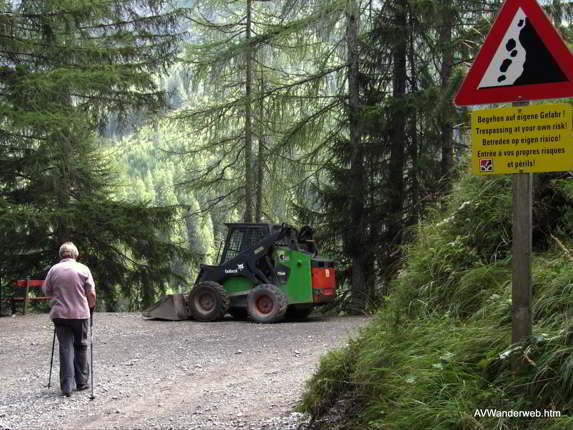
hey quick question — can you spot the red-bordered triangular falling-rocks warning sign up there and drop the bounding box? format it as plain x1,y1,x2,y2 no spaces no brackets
455,0,573,106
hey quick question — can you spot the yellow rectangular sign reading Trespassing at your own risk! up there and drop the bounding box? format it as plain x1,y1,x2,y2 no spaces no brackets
472,104,573,175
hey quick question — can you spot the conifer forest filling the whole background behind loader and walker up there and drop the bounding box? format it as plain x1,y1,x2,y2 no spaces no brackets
0,0,571,313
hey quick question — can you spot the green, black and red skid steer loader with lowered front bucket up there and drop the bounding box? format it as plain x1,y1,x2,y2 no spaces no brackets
143,223,336,323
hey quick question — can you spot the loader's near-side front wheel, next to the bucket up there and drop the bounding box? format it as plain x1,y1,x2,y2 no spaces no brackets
189,281,229,321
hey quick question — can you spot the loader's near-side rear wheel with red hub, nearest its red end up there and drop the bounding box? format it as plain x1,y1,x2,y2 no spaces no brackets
247,284,288,324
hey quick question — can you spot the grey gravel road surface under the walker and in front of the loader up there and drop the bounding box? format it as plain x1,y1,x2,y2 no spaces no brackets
0,313,368,430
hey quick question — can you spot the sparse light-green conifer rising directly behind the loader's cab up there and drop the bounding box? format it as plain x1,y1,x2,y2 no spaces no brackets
173,0,344,221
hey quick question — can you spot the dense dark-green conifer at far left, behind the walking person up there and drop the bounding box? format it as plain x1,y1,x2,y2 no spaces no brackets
0,0,192,310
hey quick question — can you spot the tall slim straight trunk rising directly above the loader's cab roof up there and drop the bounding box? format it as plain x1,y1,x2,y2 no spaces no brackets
244,0,254,222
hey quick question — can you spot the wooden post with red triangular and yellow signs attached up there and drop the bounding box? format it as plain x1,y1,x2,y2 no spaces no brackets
455,0,573,350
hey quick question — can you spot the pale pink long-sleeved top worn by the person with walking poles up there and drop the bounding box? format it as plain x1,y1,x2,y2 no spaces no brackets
42,258,95,319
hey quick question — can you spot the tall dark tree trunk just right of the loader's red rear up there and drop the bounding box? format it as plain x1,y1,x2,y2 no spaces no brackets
346,0,368,314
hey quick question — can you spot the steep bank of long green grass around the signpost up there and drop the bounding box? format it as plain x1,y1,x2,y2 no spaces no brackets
301,171,573,430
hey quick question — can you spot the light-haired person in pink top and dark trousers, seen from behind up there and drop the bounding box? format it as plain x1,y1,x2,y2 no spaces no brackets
42,242,96,397
